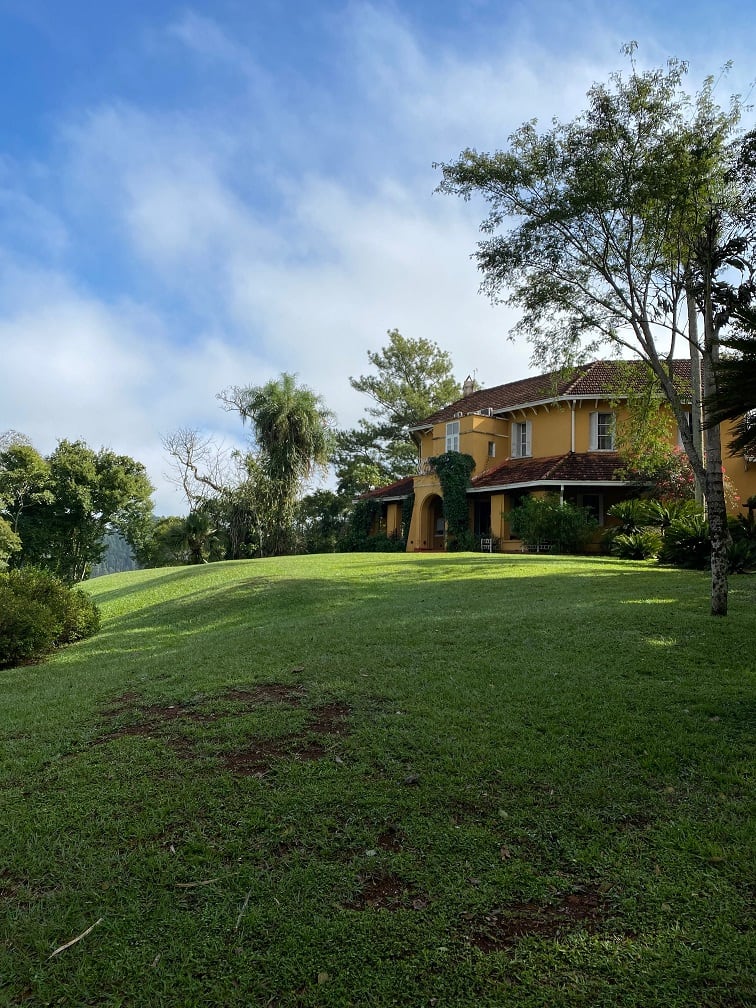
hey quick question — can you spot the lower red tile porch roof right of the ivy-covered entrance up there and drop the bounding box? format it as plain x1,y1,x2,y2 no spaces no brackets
472,452,622,490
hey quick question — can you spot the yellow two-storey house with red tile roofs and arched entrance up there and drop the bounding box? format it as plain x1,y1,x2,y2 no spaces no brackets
358,361,756,551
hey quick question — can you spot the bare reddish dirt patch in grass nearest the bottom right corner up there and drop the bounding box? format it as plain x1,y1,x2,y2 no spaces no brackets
461,888,607,953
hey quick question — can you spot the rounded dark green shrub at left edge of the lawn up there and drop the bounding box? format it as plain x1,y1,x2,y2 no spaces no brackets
0,568,100,667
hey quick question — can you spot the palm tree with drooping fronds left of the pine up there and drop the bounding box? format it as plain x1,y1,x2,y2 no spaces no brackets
219,373,333,553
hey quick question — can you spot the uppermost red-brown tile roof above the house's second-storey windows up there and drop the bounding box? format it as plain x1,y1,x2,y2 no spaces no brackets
412,360,690,430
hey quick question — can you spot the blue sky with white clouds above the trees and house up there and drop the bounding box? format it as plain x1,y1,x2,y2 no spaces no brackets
0,0,756,513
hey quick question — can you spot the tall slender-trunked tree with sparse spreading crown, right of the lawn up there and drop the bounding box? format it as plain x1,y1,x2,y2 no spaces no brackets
439,55,753,615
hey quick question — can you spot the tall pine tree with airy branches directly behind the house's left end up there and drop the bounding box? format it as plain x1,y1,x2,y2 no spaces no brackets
334,329,460,496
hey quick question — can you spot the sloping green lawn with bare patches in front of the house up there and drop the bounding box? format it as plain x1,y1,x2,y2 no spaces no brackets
0,554,756,1008
